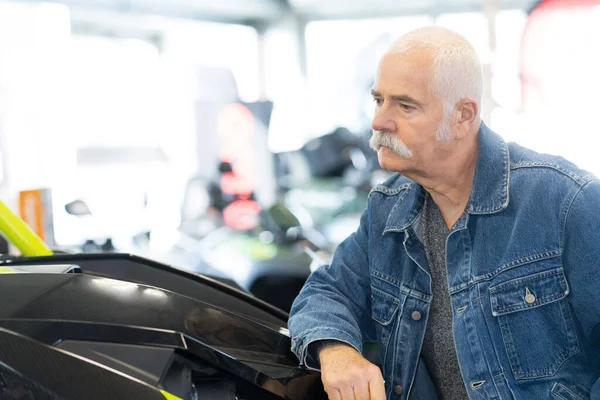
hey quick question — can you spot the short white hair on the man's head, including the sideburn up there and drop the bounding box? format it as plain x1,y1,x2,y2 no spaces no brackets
388,27,483,140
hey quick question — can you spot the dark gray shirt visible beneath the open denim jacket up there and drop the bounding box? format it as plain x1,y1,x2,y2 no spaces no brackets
421,194,469,400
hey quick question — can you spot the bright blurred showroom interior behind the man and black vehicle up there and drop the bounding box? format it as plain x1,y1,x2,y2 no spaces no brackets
0,0,600,309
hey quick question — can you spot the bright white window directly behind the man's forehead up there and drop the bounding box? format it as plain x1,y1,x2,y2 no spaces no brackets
306,16,433,135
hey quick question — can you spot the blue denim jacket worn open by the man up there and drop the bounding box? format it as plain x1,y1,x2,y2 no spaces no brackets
289,124,600,400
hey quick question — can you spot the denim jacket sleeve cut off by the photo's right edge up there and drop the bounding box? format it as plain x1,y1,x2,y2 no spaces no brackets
562,179,600,399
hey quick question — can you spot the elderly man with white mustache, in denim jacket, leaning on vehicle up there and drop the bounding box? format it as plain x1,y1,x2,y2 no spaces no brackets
289,27,600,400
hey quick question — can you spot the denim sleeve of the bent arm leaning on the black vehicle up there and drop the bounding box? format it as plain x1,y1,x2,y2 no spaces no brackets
288,204,372,369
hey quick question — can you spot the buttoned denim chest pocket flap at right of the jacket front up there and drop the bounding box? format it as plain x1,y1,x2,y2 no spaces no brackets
490,267,569,317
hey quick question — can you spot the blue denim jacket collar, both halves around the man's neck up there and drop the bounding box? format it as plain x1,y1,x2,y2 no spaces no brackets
384,122,510,233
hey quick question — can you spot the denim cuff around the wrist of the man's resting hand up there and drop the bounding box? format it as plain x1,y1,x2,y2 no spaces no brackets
292,328,362,371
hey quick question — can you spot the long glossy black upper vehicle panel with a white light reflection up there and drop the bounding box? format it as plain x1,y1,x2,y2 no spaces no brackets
0,274,290,365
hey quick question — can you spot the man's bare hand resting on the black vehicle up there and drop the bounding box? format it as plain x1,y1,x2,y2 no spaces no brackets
319,345,385,400
